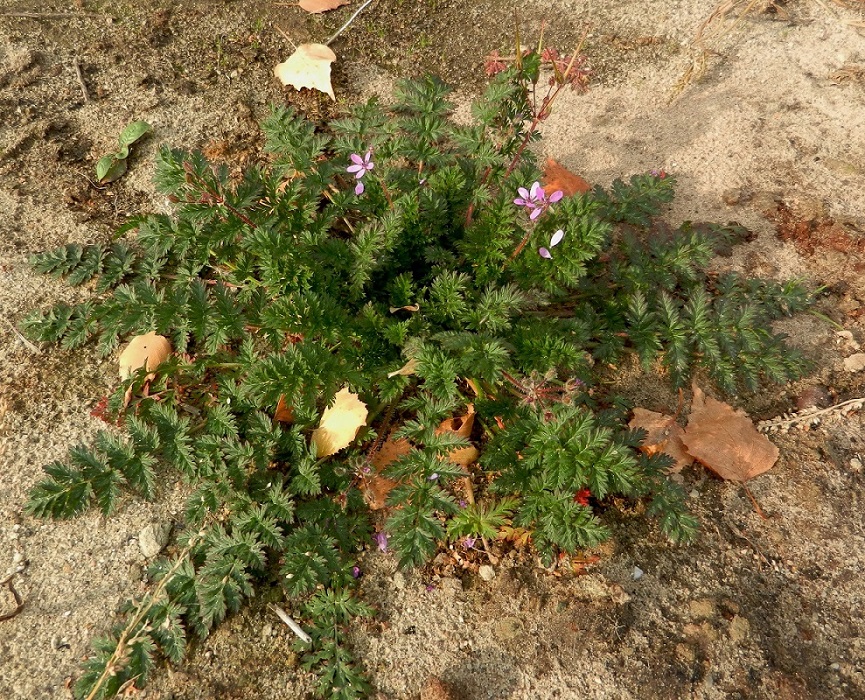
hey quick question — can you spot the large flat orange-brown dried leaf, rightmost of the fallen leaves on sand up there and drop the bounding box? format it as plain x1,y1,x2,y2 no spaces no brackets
682,384,778,482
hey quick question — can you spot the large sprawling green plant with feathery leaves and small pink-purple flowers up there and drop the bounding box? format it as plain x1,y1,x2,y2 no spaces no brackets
21,52,809,698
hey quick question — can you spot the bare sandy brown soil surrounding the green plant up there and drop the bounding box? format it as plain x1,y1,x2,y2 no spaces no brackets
0,0,865,700
